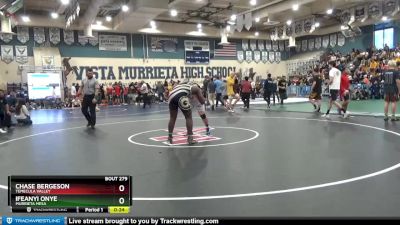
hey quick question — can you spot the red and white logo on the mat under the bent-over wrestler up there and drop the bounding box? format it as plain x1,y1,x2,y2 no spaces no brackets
149,127,221,146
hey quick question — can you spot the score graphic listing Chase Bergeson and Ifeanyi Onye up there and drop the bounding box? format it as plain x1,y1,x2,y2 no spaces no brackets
8,176,132,213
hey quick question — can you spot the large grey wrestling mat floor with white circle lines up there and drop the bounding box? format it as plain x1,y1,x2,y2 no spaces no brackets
0,105,400,217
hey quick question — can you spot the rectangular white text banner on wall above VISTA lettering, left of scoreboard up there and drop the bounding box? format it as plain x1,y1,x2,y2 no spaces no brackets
99,34,128,52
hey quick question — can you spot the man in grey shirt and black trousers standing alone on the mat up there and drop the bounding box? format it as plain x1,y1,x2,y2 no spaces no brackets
78,68,99,129
